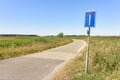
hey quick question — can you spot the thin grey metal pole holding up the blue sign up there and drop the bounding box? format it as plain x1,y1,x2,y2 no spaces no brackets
85,27,90,74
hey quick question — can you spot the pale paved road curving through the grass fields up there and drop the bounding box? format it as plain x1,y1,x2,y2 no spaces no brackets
0,40,86,80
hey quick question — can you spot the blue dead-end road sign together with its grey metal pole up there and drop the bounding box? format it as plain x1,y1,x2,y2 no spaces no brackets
85,12,95,74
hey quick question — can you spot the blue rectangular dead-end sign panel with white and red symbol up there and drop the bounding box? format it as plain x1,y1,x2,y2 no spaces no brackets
85,12,95,27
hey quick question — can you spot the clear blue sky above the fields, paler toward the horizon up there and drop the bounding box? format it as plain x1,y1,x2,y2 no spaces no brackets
0,0,120,35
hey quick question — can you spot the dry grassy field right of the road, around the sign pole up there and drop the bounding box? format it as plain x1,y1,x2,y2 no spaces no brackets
53,36,120,80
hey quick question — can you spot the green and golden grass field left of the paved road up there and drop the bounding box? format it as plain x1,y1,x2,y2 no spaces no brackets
0,36,72,60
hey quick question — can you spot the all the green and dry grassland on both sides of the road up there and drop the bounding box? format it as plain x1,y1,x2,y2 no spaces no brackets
0,36,120,80
